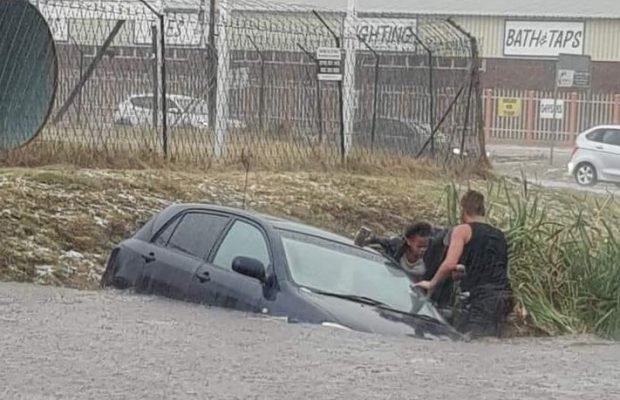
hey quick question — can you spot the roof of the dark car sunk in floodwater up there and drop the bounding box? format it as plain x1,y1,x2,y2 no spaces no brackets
169,203,355,246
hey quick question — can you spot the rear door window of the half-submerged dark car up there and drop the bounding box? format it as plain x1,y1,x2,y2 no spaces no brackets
164,212,229,258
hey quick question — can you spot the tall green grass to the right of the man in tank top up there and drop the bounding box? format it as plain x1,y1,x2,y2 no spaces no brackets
446,180,620,339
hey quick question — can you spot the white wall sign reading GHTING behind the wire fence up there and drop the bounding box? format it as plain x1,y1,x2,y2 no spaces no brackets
356,18,418,51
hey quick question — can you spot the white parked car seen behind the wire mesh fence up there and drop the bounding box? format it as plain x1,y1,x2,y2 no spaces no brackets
114,93,245,128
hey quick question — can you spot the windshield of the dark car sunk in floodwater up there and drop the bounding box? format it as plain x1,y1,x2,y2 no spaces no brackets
282,231,441,319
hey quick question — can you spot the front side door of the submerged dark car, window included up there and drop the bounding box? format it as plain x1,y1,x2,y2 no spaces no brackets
190,219,273,313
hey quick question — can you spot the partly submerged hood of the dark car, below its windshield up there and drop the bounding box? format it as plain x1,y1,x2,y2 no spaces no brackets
300,289,463,340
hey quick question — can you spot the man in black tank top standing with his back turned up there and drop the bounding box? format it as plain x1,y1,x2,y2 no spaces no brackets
416,190,511,337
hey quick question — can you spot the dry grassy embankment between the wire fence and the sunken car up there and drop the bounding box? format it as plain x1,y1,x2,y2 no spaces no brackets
0,164,452,288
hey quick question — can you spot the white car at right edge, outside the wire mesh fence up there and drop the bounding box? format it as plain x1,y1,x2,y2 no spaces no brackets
568,125,620,186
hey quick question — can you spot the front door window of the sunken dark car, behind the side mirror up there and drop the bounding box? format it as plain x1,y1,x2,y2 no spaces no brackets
213,221,271,271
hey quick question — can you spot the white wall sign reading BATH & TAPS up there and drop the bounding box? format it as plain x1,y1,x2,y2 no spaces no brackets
504,21,585,57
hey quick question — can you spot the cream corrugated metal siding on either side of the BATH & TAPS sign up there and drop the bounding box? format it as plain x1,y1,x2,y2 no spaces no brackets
454,16,620,62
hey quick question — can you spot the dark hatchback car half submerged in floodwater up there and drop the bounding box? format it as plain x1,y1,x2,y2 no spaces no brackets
101,204,461,340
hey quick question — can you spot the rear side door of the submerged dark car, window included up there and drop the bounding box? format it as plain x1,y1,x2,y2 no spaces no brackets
137,211,230,300
